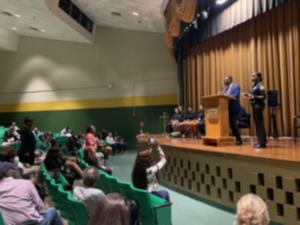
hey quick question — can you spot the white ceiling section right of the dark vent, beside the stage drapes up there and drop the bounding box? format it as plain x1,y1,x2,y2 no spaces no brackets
72,0,165,33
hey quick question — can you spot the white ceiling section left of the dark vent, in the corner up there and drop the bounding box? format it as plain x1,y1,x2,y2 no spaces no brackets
0,0,90,43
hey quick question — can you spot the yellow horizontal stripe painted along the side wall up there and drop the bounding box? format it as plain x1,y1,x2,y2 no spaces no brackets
0,95,178,112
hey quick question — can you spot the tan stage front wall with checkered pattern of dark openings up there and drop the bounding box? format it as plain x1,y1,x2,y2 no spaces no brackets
138,140,300,225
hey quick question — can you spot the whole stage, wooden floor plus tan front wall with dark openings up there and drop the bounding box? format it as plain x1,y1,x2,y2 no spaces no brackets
137,134,300,224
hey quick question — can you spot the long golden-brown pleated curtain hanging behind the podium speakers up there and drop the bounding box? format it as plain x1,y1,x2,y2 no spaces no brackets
183,0,300,136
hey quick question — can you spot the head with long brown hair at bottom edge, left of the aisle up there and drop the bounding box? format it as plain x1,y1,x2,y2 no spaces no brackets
89,193,130,225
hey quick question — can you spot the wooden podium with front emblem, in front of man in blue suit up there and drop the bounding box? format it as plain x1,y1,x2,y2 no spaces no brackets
202,95,236,146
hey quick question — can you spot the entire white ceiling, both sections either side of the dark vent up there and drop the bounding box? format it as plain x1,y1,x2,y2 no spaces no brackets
0,0,164,43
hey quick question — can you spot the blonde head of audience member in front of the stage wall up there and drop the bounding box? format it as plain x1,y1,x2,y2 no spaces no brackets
234,194,270,225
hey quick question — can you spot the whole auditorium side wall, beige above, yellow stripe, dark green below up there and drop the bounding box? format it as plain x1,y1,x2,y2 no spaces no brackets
0,28,178,148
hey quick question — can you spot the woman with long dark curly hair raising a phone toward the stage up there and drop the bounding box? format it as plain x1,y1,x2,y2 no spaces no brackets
132,138,170,202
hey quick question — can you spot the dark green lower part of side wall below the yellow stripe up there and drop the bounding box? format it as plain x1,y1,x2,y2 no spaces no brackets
0,105,175,149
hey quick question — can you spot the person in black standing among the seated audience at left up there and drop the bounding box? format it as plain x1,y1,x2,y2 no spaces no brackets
19,116,35,165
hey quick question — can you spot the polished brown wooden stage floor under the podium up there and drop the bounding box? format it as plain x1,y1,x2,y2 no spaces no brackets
137,134,300,163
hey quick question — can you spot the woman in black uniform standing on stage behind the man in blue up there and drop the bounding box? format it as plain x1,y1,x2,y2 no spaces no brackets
244,72,267,148
